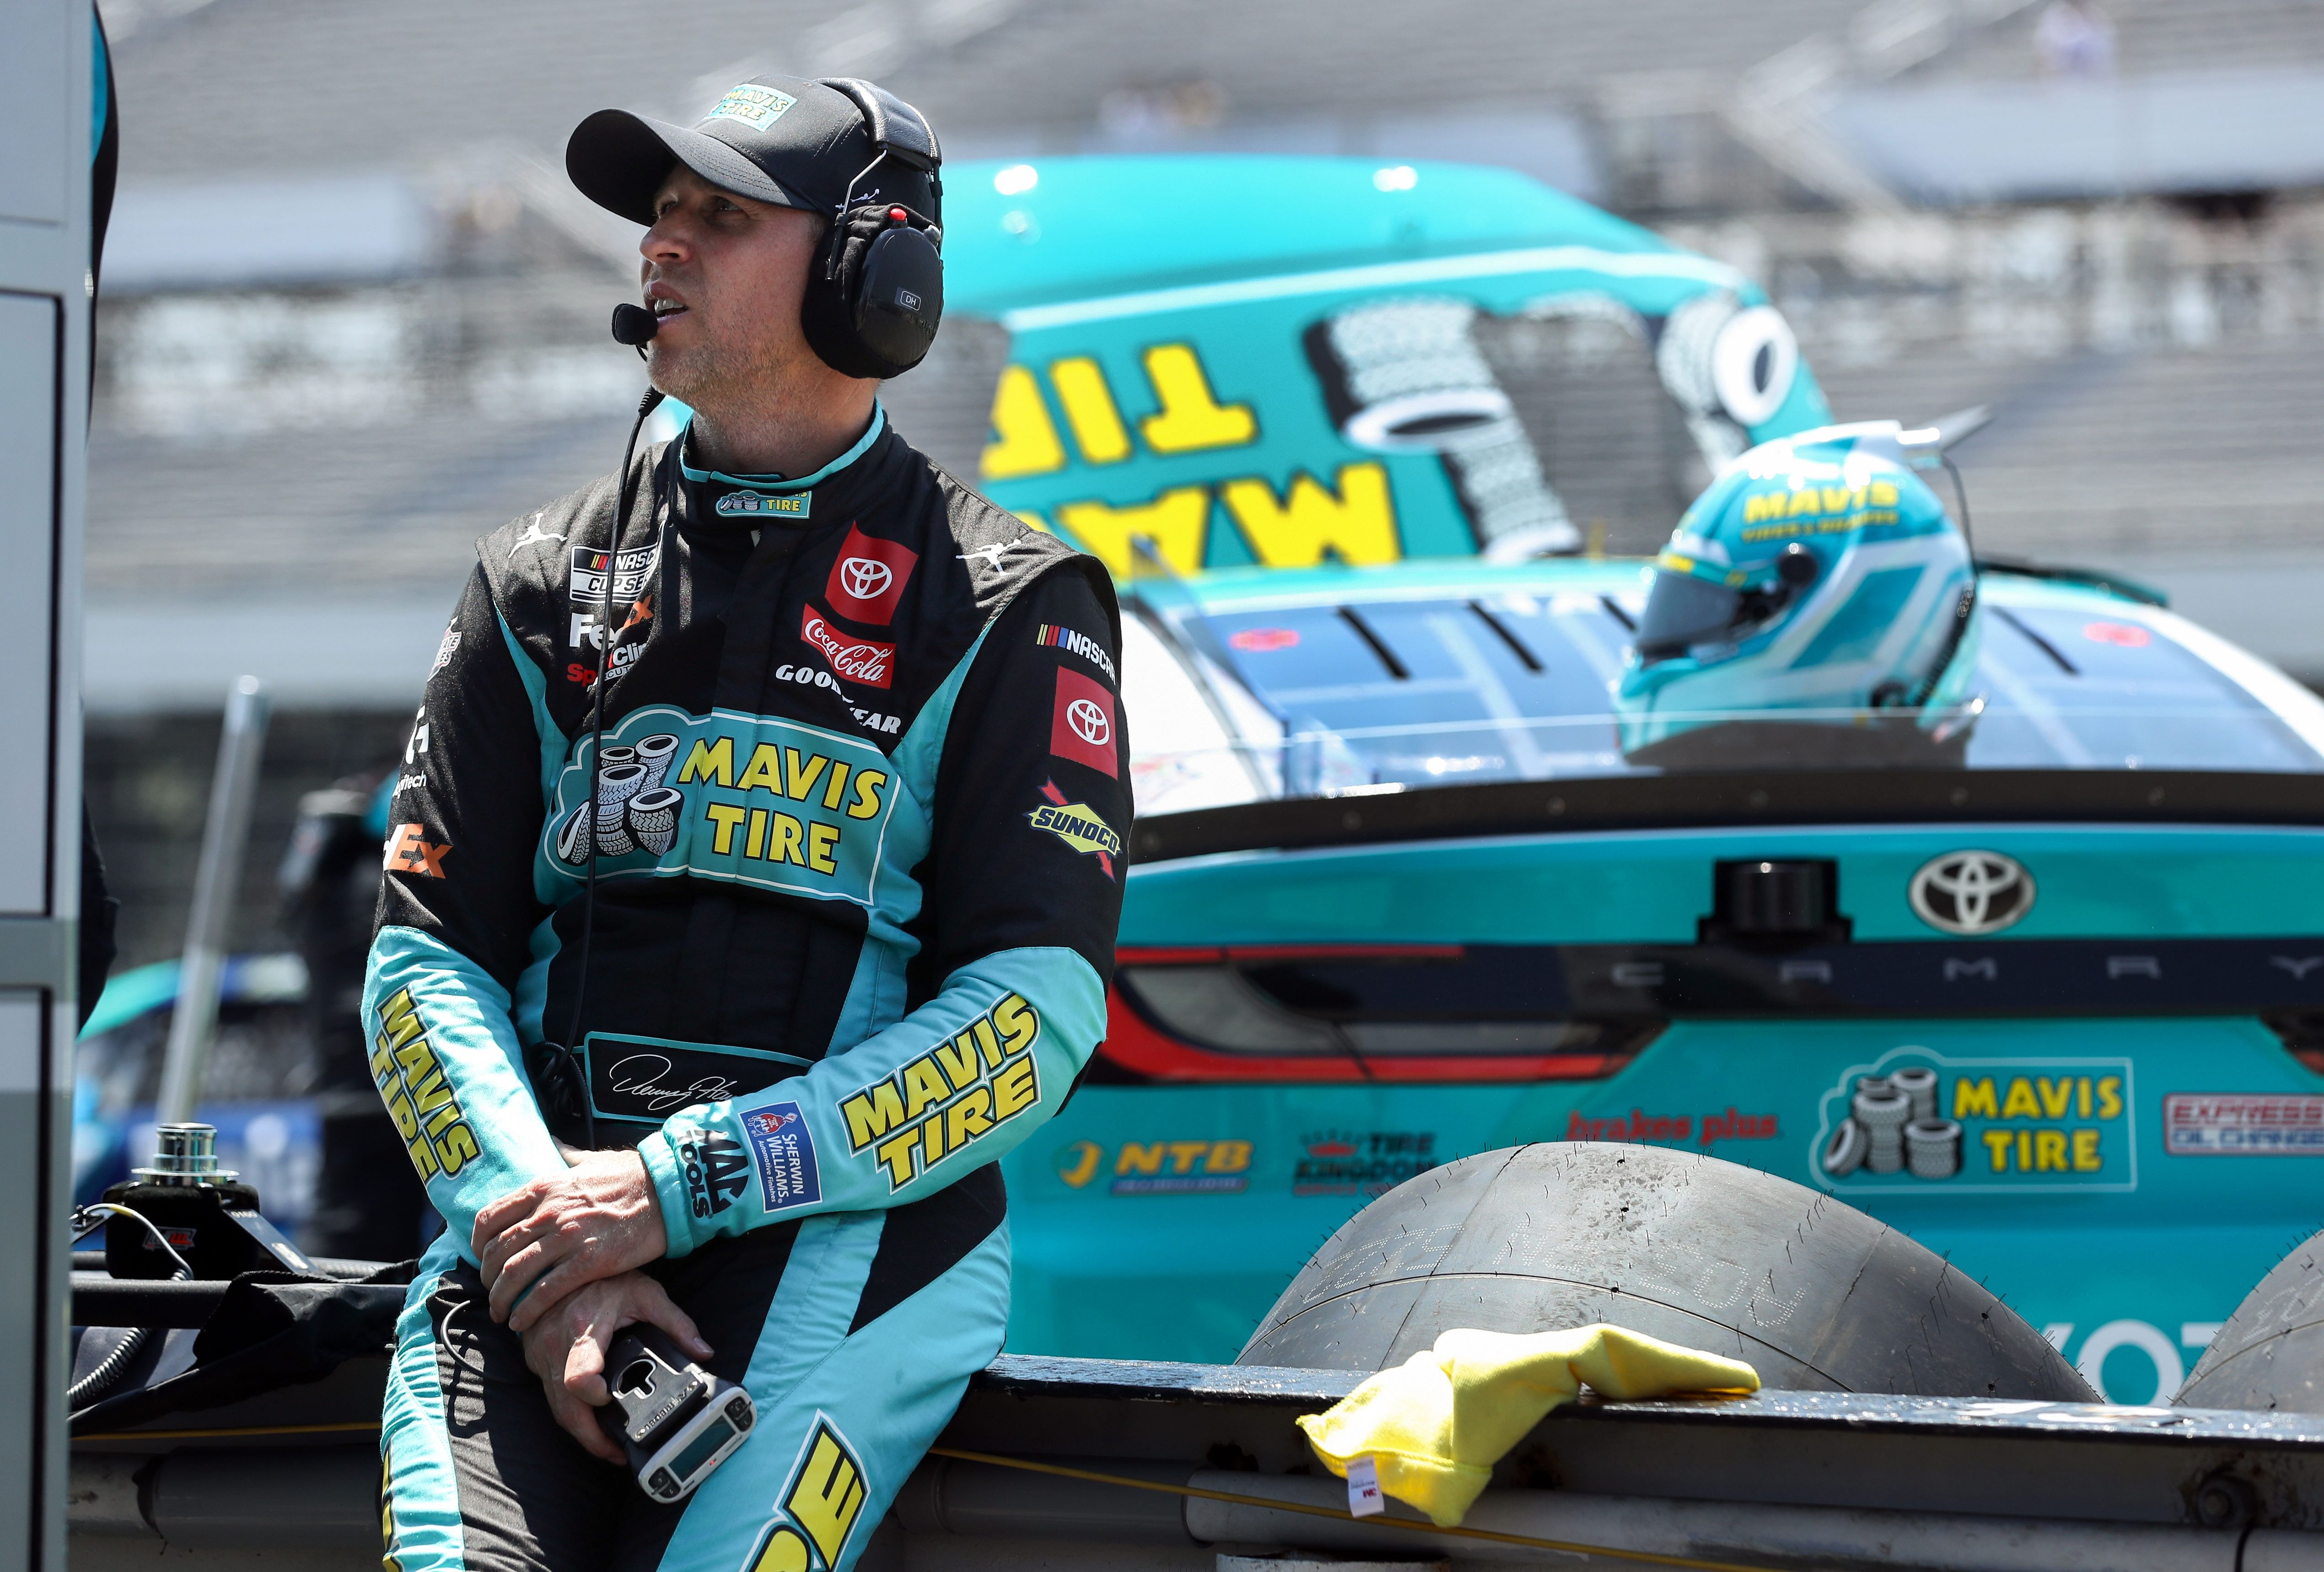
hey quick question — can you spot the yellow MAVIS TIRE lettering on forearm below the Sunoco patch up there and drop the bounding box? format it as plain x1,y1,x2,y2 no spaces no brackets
839,993,1041,1193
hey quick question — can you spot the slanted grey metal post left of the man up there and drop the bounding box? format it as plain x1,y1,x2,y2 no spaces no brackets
156,677,267,1125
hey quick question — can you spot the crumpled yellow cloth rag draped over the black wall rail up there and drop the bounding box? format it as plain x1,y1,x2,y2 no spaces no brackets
1299,1325,1759,1528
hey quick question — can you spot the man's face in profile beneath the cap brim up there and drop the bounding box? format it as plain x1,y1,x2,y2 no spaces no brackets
637,163,825,407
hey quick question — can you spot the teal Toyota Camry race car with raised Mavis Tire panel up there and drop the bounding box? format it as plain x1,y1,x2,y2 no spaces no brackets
930,158,2324,1402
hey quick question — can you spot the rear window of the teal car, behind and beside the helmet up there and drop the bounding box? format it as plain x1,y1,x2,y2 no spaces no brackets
1125,574,2324,814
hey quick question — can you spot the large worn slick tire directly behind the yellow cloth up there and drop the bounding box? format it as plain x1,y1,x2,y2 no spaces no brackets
1237,1142,2101,1402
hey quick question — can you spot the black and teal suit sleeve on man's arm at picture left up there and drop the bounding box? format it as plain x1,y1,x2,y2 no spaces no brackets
362,567,567,1258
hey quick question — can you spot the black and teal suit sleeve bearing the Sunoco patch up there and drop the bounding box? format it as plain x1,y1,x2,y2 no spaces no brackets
639,570,1130,1256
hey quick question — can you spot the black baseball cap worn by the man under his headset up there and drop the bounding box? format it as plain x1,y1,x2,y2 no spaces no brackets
565,77,939,223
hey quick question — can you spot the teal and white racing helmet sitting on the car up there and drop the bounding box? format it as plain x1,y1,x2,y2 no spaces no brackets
1615,421,1978,767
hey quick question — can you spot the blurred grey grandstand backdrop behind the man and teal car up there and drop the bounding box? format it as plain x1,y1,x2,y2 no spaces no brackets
86,0,2324,1246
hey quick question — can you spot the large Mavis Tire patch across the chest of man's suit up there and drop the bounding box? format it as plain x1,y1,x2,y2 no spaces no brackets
542,705,897,907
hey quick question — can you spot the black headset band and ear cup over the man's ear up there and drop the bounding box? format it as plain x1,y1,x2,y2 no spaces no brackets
800,77,943,377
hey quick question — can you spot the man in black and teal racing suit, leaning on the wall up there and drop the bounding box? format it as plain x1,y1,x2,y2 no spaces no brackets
365,77,1130,1572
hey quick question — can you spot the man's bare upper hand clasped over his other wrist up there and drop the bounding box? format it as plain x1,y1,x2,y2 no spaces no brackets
469,1151,667,1332
